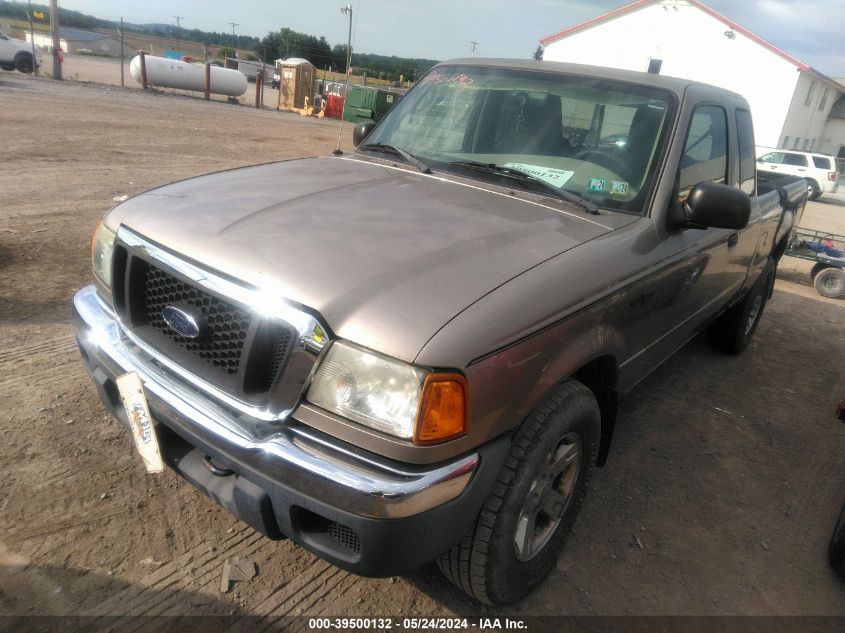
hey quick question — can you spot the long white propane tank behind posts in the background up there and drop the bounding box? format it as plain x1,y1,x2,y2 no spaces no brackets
129,55,247,97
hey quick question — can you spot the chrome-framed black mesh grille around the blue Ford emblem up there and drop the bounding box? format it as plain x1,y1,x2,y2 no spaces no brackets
112,227,331,420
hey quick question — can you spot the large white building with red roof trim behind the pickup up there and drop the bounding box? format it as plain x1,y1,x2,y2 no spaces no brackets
540,0,845,160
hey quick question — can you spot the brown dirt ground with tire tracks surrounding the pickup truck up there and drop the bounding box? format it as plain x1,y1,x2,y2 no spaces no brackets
0,69,845,628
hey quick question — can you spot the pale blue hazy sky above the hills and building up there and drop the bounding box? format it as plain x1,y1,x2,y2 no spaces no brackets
51,0,845,77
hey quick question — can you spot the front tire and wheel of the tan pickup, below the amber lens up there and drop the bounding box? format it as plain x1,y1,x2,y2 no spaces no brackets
437,380,601,604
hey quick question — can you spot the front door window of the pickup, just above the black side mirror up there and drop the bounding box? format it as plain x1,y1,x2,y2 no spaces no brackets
678,106,728,196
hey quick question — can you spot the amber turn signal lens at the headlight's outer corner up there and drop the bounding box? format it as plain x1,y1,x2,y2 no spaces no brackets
414,374,467,443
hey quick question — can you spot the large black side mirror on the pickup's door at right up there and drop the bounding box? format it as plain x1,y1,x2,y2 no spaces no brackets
677,182,751,230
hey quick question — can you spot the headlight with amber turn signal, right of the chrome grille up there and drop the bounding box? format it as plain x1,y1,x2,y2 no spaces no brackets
308,341,466,442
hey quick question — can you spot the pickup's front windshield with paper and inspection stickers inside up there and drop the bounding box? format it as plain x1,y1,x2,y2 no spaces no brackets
366,66,672,213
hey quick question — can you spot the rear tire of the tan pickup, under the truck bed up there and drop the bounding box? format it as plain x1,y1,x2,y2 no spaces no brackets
707,259,775,354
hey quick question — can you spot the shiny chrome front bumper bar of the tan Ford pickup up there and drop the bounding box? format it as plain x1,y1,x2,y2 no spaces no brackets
73,286,479,519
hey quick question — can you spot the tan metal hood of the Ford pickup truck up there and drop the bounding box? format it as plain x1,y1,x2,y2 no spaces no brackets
107,157,617,361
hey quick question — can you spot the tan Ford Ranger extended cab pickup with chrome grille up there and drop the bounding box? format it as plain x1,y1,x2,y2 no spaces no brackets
74,59,807,603
